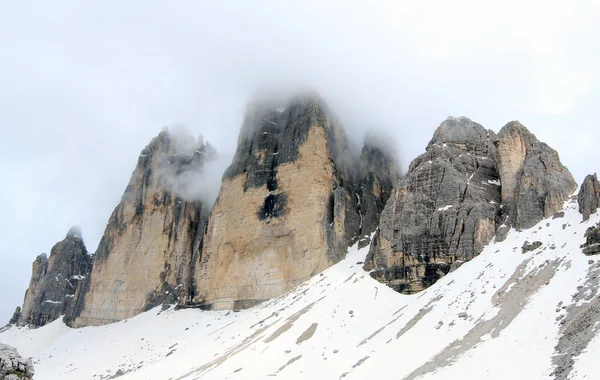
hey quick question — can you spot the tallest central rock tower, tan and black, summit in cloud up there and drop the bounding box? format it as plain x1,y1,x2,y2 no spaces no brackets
190,95,395,309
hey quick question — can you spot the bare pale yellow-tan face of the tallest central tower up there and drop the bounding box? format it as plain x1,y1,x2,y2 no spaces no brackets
194,125,344,309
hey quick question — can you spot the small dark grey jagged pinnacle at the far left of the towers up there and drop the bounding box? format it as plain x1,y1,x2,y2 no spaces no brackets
18,227,92,327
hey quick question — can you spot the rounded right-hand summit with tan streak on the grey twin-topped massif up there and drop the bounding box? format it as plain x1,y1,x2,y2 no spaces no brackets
495,121,577,229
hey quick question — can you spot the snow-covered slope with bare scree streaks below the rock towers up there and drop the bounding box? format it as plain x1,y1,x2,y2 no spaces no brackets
0,197,600,380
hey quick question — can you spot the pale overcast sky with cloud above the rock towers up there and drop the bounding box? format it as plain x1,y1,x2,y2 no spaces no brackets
0,0,600,325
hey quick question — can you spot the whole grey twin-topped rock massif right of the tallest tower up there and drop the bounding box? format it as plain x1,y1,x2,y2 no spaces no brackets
365,118,576,293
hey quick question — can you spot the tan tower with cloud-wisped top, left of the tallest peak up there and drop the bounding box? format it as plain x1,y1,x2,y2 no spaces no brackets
66,130,215,327
